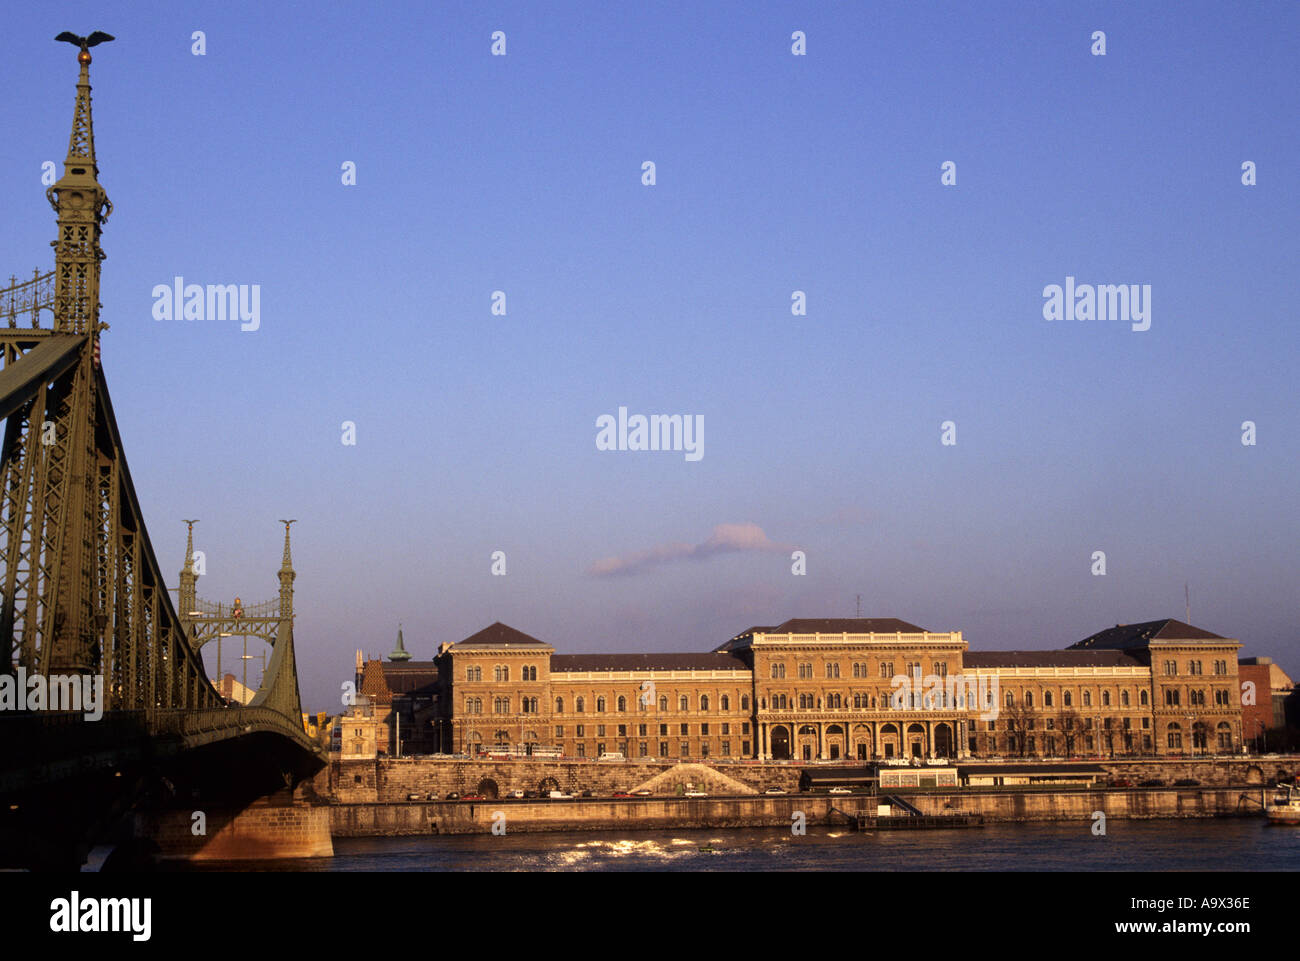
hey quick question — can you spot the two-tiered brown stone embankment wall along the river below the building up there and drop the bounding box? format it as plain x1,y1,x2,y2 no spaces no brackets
315,757,1296,837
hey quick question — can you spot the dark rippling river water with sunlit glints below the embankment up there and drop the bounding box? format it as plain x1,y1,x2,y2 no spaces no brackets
172,818,1300,871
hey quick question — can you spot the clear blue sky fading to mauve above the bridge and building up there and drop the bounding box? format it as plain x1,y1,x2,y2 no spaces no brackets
0,3,1300,710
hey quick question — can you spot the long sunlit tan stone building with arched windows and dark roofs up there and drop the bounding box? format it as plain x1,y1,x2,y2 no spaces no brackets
358,618,1249,761
